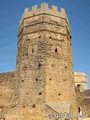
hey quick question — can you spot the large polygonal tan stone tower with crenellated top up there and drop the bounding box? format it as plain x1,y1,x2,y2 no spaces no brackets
2,3,77,120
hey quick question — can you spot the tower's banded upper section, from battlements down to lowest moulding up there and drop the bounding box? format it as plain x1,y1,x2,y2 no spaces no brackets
18,3,71,47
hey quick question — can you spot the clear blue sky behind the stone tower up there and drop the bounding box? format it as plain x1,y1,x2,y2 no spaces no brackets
0,0,90,88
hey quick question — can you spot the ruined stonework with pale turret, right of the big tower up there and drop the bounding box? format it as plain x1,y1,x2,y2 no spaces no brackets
74,72,90,117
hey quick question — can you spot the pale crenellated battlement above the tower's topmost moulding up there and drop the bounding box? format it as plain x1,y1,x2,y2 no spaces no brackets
20,3,68,25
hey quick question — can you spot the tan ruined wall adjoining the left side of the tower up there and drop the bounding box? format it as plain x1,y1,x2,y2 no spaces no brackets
0,72,15,109
